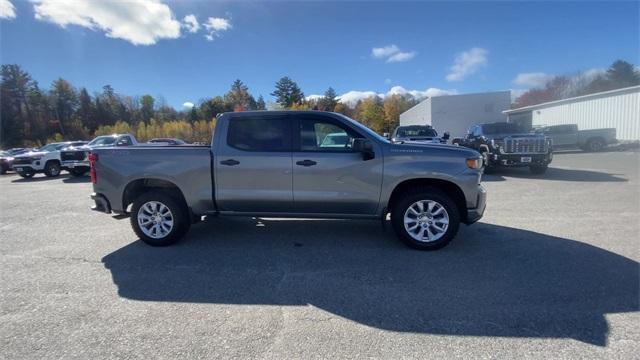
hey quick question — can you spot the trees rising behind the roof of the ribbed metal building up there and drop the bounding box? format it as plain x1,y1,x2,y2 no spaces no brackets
511,60,640,108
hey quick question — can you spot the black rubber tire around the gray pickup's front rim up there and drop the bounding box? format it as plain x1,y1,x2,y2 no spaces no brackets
391,187,460,250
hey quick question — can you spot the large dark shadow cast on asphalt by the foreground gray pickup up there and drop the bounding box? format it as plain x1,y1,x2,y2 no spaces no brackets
102,218,640,346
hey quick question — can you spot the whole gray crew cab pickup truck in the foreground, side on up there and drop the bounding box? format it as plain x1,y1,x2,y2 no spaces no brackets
89,111,486,250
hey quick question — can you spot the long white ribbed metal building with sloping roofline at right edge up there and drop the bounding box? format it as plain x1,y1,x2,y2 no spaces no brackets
504,86,640,140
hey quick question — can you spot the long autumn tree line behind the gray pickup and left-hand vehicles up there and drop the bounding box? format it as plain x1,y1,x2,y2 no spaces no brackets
0,64,418,148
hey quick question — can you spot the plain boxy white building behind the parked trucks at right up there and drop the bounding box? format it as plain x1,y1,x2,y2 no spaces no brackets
400,91,511,137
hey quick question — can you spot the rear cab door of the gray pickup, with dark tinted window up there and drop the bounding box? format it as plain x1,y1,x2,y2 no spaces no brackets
214,114,293,212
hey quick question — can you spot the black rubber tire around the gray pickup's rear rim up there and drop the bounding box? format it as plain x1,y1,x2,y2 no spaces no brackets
131,191,191,246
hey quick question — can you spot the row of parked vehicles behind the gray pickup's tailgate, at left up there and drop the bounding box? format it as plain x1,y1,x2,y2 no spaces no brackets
0,134,185,178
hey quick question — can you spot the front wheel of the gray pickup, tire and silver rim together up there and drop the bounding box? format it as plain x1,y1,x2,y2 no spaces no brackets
391,188,460,250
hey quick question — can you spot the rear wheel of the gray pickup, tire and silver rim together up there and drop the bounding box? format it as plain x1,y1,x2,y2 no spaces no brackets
131,191,191,246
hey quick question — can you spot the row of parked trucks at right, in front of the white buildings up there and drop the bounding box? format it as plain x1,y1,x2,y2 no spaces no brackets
390,122,617,174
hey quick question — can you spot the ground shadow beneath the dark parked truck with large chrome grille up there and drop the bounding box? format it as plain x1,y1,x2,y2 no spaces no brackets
482,167,628,182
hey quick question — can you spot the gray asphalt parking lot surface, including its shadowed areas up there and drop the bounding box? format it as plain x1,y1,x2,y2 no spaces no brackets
0,152,640,359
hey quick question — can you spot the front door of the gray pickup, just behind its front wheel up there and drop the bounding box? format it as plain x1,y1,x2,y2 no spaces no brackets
293,114,382,215
